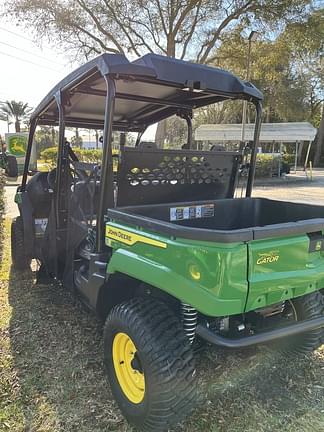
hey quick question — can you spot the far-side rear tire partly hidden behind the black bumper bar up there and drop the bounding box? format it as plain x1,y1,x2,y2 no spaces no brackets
284,291,324,354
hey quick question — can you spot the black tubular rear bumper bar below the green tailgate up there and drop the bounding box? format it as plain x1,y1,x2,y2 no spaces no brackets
196,316,324,348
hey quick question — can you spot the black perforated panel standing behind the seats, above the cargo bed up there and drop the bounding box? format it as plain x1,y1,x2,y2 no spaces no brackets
117,147,242,206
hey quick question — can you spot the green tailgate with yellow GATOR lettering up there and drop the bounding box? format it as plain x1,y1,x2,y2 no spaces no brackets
246,233,324,311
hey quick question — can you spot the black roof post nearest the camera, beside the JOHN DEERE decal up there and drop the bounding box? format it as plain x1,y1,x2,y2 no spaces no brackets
96,75,116,253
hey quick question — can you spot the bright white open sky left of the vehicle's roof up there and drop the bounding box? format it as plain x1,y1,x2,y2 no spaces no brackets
0,18,77,135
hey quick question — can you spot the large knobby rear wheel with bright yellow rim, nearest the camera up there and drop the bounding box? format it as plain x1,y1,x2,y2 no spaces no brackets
104,297,196,432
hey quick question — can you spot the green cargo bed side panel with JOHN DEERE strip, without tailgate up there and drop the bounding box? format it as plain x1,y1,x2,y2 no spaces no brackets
106,223,248,316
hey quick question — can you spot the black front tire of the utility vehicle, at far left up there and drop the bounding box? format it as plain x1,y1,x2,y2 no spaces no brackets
11,216,31,270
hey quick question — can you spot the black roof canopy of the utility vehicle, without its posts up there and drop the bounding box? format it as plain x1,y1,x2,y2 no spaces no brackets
32,54,262,131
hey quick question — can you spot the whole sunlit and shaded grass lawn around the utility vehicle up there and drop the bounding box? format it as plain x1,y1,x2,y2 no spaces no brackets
0,221,324,432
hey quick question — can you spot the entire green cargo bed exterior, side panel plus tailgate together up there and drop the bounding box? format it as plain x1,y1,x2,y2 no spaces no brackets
106,222,324,317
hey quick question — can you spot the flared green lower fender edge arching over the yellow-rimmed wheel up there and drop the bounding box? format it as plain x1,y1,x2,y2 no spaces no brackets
107,248,242,316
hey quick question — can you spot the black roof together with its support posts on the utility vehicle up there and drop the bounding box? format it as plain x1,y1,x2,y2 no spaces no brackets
21,54,263,253
